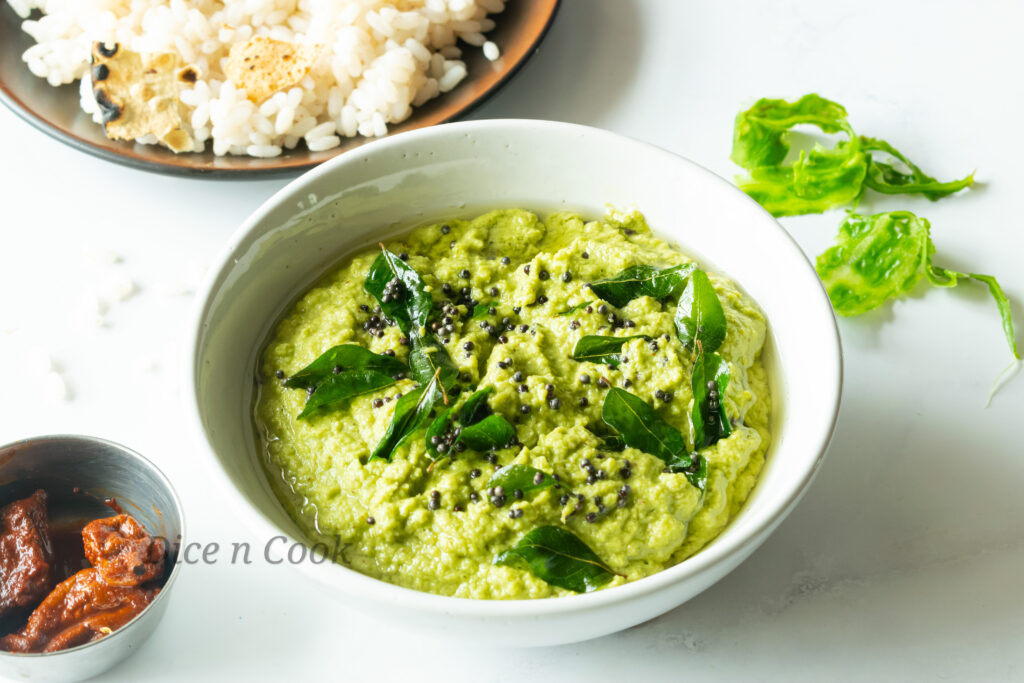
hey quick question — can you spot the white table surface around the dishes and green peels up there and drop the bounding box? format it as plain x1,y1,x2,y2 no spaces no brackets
0,0,1024,681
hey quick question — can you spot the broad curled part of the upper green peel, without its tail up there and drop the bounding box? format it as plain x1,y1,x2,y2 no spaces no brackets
731,94,868,216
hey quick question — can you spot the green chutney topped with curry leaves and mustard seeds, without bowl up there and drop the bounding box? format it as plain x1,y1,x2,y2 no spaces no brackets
256,209,770,599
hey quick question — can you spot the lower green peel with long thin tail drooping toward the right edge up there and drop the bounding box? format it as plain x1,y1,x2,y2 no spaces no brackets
816,211,1021,358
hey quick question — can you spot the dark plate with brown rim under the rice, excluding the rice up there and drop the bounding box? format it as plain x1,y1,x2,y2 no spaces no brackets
0,0,560,178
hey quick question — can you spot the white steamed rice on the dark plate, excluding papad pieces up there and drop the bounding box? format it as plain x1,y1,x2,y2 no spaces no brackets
7,0,506,157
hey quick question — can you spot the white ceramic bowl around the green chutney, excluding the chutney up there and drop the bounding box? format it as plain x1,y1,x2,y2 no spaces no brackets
186,120,842,645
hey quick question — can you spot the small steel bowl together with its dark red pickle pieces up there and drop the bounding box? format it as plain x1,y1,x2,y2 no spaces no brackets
0,435,184,681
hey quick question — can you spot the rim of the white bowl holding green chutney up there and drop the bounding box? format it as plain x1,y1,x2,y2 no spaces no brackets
181,119,843,618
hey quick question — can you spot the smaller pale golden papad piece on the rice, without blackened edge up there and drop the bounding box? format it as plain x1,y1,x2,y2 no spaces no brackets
224,36,321,104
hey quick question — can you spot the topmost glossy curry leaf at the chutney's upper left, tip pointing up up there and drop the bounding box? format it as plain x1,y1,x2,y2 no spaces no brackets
364,245,434,335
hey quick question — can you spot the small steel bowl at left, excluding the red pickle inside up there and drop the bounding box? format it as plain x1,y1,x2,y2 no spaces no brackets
0,435,184,681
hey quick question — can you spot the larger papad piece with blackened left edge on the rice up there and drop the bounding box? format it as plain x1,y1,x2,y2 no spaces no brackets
92,43,195,153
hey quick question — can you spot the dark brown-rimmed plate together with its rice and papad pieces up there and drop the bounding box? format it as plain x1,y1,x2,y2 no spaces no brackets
0,0,559,177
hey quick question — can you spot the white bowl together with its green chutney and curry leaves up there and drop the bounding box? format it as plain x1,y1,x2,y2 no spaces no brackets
186,121,842,645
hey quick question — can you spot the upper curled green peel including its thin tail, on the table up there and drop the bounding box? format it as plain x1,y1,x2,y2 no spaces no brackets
731,94,974,216
